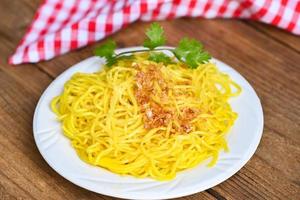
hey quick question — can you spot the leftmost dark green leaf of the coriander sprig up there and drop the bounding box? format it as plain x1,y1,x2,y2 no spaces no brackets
94,40,116,66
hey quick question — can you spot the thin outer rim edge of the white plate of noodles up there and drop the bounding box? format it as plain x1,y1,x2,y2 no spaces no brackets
33,46,264,199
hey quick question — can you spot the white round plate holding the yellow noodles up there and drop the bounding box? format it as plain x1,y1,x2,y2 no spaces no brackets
33,47,263,199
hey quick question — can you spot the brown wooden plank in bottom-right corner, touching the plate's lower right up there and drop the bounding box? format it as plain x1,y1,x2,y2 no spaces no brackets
213,156,300,200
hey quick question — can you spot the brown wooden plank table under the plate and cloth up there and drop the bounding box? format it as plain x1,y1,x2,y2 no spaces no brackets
0,0,300,200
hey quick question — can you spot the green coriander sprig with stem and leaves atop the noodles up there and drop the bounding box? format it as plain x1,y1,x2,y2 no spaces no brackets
95,23,211,69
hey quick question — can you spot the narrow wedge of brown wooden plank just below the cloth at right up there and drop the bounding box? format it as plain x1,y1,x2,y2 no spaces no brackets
247,21,300,53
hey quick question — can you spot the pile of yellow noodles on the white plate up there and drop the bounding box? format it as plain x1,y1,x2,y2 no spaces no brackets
51,54,241,180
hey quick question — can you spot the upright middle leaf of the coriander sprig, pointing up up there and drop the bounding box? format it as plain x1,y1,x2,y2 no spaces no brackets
144,23,166,50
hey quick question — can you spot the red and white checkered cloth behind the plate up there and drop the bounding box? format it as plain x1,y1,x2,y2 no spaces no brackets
9,0,300,64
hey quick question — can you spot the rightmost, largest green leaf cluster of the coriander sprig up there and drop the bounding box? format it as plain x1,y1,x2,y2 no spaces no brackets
173,38,211,69
